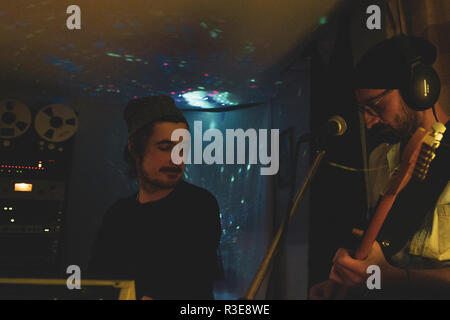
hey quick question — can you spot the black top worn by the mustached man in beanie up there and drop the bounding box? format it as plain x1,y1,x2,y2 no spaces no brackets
89,181,221,299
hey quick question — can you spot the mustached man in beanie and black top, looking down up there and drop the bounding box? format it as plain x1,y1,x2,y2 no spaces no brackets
89,96,221,299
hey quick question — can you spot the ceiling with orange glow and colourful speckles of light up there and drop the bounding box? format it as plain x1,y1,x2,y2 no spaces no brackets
0,0,343,108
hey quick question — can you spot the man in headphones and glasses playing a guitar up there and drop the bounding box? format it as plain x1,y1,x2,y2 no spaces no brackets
310,35,450,299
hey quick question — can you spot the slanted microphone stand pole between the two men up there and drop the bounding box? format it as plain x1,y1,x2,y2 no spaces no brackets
244,150,326,300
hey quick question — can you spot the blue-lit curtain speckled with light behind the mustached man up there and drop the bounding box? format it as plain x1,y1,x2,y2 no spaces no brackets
184,105,271,299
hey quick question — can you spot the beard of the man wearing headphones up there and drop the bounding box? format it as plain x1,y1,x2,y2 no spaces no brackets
370,101,419,144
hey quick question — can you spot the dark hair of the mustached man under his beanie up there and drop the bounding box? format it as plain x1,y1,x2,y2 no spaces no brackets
123,116,189,179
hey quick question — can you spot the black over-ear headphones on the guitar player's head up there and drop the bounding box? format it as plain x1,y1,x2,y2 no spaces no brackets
398,35,441,111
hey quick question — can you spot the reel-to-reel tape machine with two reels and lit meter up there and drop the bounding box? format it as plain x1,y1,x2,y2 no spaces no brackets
0,99,78,277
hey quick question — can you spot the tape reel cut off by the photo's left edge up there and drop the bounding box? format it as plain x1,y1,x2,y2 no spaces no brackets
0,99,32,139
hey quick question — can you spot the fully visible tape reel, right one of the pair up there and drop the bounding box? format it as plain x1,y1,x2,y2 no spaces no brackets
34,104,78,142
